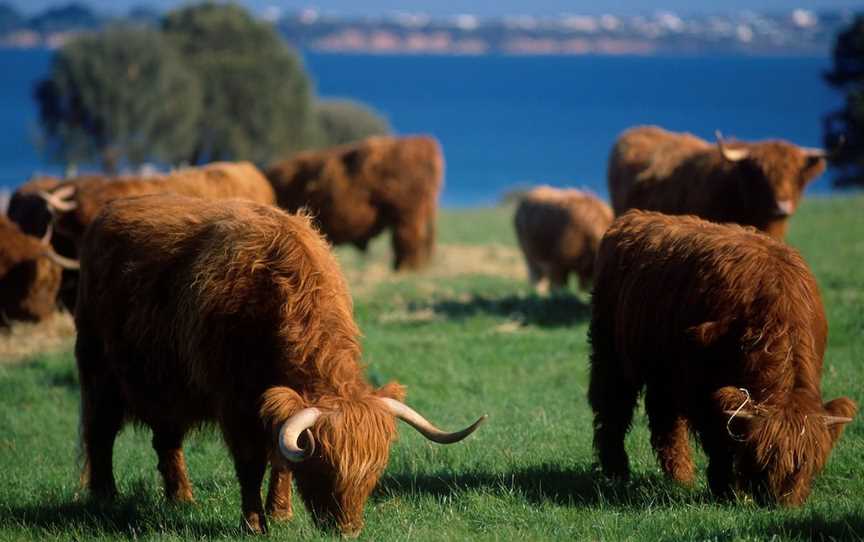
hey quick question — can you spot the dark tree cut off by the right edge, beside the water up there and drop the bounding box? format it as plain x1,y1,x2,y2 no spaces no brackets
825,15,864,186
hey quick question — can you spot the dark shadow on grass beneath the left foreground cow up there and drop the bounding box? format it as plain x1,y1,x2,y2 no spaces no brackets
0,485,240,538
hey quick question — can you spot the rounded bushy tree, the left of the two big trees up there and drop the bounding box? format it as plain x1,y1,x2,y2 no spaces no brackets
35,26,201,172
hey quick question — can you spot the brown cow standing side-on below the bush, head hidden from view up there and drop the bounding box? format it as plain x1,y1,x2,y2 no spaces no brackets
267,136,444,269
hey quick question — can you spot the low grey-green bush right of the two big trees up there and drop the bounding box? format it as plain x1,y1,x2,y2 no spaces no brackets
315,100,390,146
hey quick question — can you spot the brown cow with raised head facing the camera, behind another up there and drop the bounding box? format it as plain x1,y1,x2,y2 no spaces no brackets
608,126,825,240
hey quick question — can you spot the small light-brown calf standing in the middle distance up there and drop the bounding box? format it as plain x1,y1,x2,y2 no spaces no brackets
513,186,612,290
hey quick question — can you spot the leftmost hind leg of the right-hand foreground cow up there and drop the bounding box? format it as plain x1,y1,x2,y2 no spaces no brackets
588,348,639,479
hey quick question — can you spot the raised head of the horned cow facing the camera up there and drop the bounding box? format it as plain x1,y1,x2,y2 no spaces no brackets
717,133,826,240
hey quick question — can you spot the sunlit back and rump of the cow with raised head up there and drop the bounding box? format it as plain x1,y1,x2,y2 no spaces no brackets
607,126,711,216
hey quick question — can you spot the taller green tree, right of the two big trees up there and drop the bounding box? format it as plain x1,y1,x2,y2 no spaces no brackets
163,2,314,163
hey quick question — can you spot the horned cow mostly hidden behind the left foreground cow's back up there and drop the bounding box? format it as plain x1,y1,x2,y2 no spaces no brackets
36,162,276,310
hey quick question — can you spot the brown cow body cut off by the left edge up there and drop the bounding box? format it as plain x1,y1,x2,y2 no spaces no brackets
0,216,60,327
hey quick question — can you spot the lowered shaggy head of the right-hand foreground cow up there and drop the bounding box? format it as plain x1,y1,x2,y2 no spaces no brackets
716,387,857,506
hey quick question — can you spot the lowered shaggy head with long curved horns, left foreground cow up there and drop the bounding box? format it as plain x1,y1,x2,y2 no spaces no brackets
261,383,486,536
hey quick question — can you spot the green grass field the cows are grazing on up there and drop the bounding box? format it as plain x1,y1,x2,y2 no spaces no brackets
0,196,864,540
